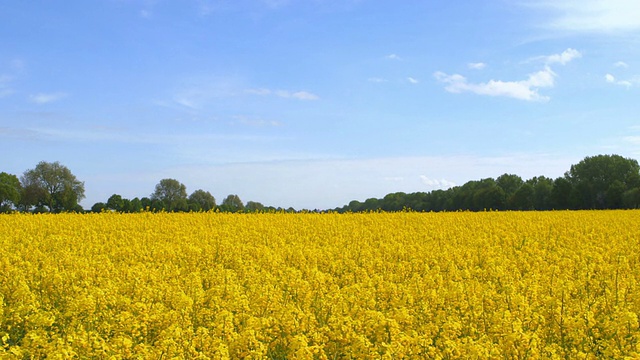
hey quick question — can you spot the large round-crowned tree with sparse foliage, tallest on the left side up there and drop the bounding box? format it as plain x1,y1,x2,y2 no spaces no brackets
20,161,84,212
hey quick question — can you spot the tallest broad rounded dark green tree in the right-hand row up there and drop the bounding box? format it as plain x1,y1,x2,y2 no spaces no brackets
565,155,640,209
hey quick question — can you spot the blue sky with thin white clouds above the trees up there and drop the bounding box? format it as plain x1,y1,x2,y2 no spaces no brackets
0,0,640,209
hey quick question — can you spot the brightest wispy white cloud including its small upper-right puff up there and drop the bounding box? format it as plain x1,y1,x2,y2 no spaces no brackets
433,48,582,102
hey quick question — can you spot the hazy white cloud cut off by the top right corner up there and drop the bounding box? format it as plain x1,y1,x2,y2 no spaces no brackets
528,0,640,33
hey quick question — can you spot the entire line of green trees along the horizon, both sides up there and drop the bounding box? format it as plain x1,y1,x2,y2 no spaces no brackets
0,155,640,213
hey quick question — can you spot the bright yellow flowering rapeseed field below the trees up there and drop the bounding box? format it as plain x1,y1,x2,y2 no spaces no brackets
0,211,640,359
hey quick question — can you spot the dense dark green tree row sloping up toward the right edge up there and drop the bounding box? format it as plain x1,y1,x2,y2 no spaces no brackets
335,155,640,212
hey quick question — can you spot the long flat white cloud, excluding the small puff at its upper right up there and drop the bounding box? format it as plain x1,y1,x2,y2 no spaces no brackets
434,67,556,101
